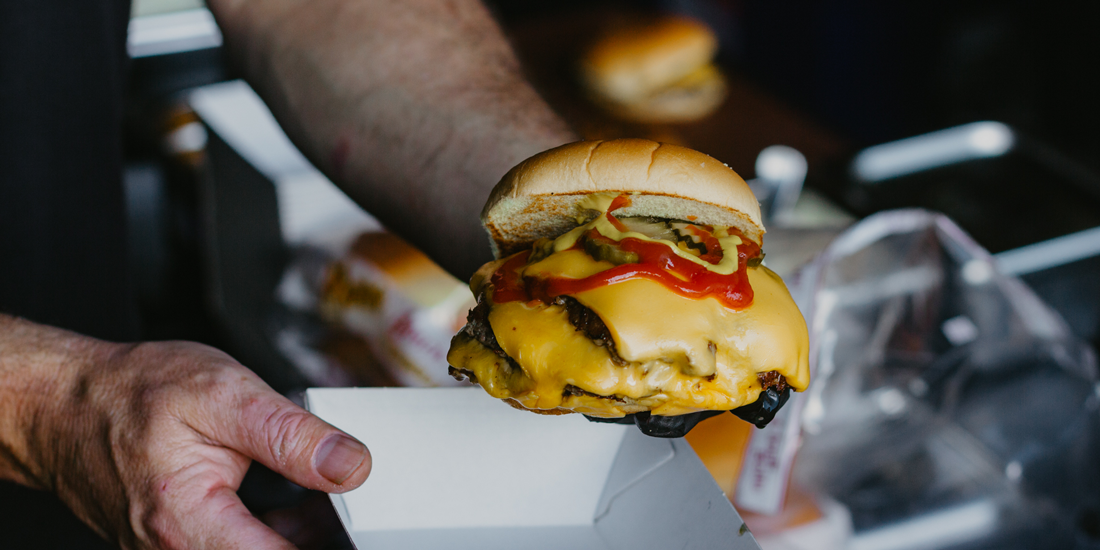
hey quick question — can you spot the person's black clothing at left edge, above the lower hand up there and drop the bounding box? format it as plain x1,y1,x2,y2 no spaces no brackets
0,0,138,340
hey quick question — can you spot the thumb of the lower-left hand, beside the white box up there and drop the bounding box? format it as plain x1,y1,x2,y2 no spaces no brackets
196,382,371,493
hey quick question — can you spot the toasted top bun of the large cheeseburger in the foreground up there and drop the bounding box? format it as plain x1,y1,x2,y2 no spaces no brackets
482,140,765,257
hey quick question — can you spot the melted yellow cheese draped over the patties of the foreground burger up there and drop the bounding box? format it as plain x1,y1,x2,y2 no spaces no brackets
448,249,810,417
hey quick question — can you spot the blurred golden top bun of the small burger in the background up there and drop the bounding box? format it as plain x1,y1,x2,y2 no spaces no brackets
581,17,718,103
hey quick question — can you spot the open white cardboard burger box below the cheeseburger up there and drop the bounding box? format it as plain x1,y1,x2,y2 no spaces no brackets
306,387,760,550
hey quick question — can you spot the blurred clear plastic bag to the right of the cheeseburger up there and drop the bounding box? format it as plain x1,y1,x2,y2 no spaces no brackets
792,210,1100,550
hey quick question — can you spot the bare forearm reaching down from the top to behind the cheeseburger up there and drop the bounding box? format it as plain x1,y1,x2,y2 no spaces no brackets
205,0,574,276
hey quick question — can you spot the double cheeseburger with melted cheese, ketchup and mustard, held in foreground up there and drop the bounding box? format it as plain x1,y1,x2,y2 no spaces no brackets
448,140,810,437
